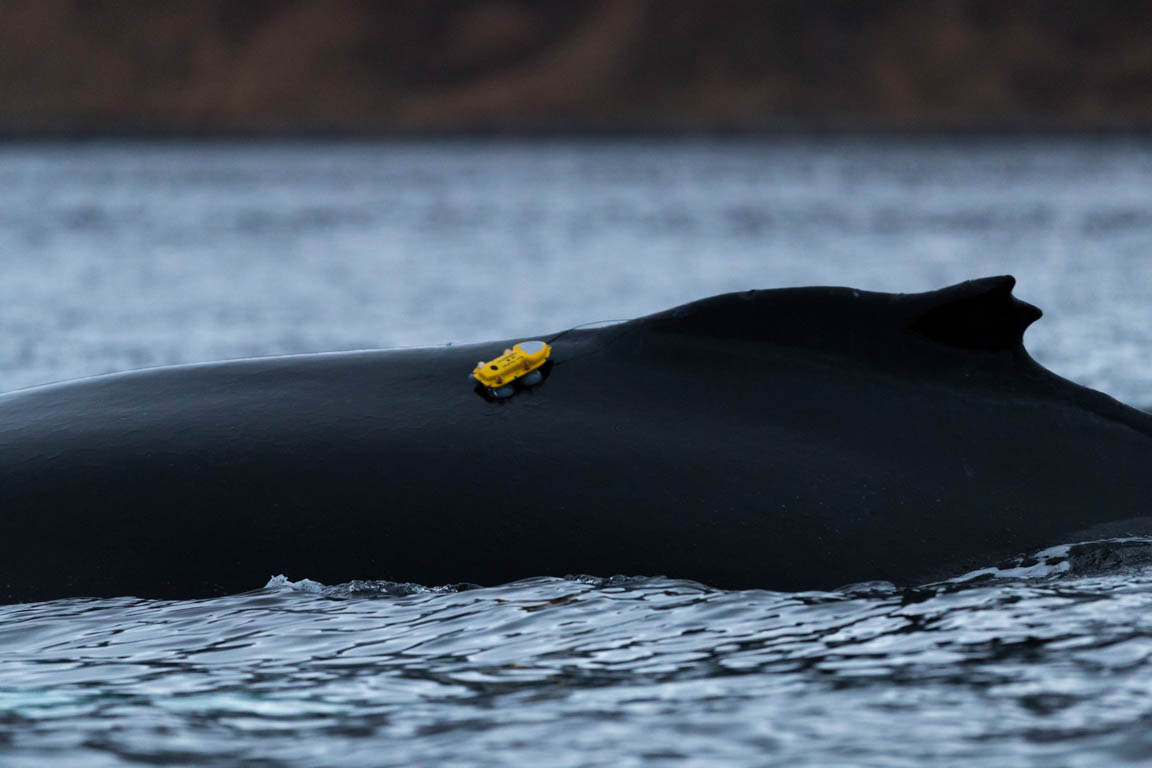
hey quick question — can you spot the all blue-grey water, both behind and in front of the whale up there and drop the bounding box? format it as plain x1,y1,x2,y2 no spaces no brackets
0,138,1152,767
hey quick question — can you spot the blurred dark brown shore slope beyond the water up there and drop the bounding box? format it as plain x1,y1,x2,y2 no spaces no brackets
0,0,1152,135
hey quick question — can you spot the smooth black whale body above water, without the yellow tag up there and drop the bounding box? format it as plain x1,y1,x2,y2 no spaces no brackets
0,276,1152,602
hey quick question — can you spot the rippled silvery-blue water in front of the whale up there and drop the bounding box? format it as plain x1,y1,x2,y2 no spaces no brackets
0,539,1152,767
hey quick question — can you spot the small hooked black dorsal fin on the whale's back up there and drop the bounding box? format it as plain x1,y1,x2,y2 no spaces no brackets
909,275,1043,350
